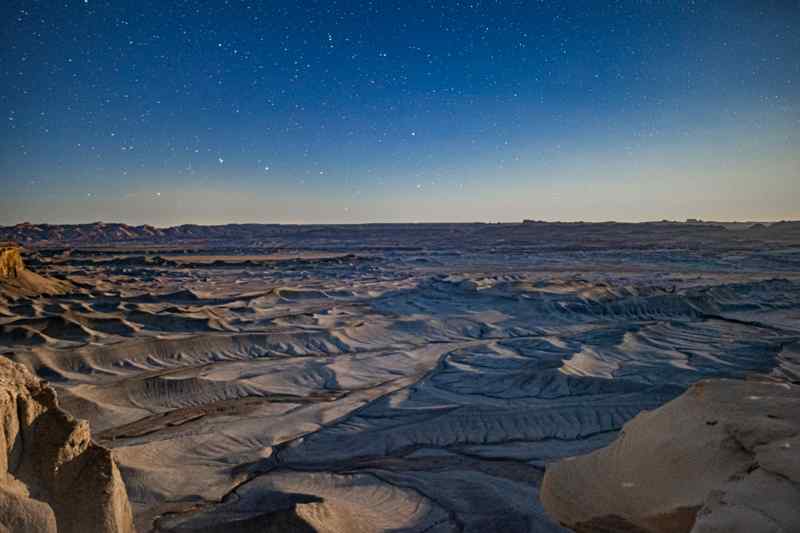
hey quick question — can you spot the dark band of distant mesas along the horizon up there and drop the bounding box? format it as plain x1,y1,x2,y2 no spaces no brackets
0,218,800,249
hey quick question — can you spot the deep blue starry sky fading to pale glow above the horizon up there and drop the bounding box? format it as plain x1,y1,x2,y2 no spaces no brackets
0,0,800,225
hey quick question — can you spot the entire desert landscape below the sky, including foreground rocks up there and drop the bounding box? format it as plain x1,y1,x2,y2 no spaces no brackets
0,218,800,533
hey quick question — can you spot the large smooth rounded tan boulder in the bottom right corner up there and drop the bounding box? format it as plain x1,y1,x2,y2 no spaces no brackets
540,380,800,533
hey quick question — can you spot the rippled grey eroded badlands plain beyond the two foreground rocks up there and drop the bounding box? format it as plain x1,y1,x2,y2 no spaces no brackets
0,219,800,533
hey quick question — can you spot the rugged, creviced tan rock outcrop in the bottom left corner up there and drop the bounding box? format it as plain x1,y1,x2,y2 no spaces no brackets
0,357,133,533
